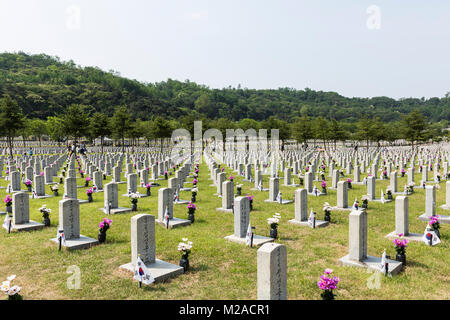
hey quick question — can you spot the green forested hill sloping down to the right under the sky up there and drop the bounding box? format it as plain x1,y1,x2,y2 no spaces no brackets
0,52,450,122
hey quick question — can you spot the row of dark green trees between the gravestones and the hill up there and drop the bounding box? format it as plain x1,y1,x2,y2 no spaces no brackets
0,94,449,156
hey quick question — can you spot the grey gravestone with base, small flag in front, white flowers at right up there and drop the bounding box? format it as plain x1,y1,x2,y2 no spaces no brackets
120,214,184,282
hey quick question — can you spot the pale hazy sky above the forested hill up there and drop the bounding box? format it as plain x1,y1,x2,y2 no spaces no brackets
0,0,450,98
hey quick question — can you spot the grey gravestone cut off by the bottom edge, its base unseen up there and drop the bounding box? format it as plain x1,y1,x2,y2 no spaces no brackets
257,243,287,300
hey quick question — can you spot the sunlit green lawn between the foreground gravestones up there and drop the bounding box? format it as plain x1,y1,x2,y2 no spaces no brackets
0,159,450,299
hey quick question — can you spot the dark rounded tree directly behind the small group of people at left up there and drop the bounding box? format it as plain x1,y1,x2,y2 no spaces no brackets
63,104,89,141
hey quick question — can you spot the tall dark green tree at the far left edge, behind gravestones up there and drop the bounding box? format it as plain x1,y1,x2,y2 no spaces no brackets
0,94,25,157
